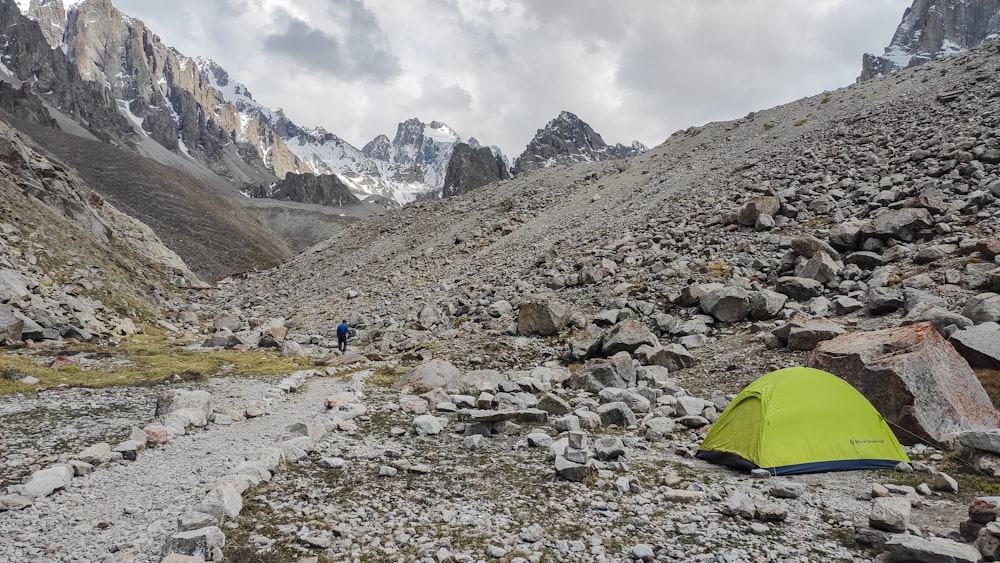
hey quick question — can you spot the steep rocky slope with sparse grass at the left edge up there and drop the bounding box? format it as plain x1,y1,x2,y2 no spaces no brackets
0,121,188,343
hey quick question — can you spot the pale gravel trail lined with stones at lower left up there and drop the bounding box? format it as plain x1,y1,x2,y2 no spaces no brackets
0,377,346,562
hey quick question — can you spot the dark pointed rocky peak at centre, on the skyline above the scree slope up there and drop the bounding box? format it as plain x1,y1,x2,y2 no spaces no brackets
514,111,646,175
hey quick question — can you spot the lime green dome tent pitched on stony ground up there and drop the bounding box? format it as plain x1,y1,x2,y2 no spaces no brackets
697,367,909,475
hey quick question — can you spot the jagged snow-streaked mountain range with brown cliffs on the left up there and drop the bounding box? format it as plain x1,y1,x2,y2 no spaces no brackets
0,0,472,204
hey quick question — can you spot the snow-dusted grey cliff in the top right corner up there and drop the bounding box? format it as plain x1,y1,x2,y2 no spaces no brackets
859,0,1000,80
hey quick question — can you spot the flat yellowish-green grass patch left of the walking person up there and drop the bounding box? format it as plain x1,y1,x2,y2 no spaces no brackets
0,329,310,395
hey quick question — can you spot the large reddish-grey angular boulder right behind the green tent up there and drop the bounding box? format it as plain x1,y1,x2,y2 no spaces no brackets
807,323,1000,444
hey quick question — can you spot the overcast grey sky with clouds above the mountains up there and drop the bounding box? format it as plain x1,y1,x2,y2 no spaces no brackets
113,0,911,157
